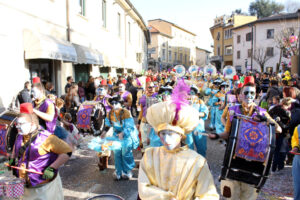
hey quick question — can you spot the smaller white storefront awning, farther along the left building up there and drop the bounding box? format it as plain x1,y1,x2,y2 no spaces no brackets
73,44,103,65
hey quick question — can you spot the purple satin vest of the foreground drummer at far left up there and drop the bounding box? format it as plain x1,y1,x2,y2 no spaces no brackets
15,130,58,187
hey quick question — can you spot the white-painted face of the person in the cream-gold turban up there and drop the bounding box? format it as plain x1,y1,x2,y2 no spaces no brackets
159,130,181,150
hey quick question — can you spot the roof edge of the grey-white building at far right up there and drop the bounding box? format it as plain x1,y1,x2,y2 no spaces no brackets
233,12,298,30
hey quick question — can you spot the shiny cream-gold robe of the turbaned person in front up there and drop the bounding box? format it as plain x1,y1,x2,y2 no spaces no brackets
138,146,219,200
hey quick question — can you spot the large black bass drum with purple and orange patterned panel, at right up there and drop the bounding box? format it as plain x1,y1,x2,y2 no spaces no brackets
220,116,275,190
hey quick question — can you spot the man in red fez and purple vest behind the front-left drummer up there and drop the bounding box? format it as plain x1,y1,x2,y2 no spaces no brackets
32,77,58,133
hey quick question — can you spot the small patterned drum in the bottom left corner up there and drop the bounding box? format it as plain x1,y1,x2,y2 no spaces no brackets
0,178,25,198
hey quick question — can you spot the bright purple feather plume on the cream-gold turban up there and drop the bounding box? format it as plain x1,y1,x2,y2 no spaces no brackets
171,79,190,126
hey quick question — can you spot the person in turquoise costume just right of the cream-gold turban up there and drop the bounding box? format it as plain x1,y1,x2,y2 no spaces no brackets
185,85,208,157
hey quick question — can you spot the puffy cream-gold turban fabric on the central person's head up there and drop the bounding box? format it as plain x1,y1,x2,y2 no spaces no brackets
146,101,199,134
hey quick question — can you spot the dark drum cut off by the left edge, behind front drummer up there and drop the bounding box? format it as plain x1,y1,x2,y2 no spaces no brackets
0,110,19,156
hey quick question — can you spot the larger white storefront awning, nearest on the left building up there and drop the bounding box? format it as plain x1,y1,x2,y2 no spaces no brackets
23,30,77,62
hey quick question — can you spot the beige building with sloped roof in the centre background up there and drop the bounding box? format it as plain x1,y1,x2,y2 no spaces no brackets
148,19,196,70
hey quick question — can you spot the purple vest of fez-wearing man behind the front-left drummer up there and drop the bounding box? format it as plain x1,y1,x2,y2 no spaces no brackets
35,99,58,133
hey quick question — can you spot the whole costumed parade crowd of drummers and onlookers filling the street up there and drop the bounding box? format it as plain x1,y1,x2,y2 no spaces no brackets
3,65,300,200
